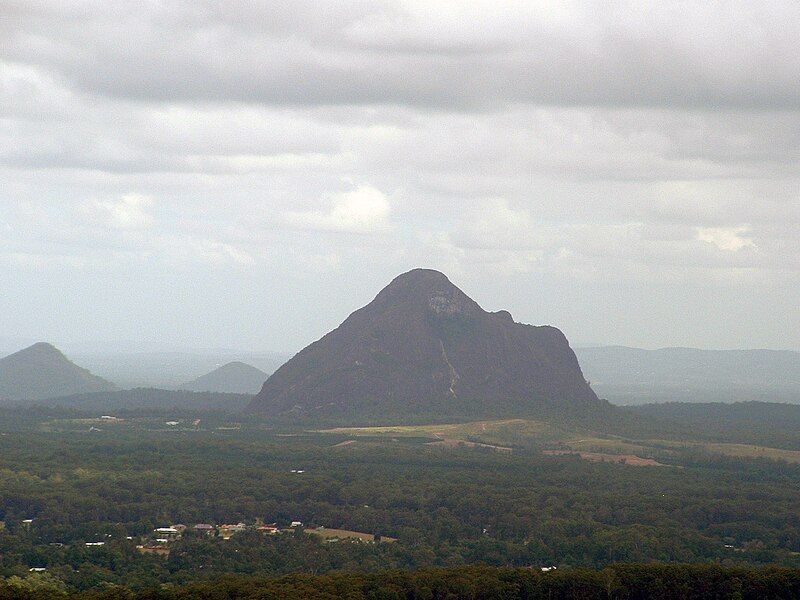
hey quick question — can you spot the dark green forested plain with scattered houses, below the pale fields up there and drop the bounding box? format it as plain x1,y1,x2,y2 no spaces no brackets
0,413,800,598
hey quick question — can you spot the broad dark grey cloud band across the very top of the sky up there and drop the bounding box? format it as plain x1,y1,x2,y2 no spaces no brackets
0,2,800,110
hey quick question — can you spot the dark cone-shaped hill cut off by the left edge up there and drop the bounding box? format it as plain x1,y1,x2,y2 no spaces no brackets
0,342,116,402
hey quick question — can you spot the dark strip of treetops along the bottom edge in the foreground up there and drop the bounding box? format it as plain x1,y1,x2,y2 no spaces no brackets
0,564,800,600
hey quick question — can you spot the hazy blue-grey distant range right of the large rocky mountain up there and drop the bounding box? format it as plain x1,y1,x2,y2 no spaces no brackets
575,346,800,404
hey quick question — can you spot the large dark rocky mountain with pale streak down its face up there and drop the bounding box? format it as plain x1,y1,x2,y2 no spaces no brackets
250,269,608,420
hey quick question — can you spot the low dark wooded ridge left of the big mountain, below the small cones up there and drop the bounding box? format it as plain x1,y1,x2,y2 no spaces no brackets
32,388,253,412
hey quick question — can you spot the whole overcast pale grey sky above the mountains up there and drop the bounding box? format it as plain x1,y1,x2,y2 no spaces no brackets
0,0,800,351
